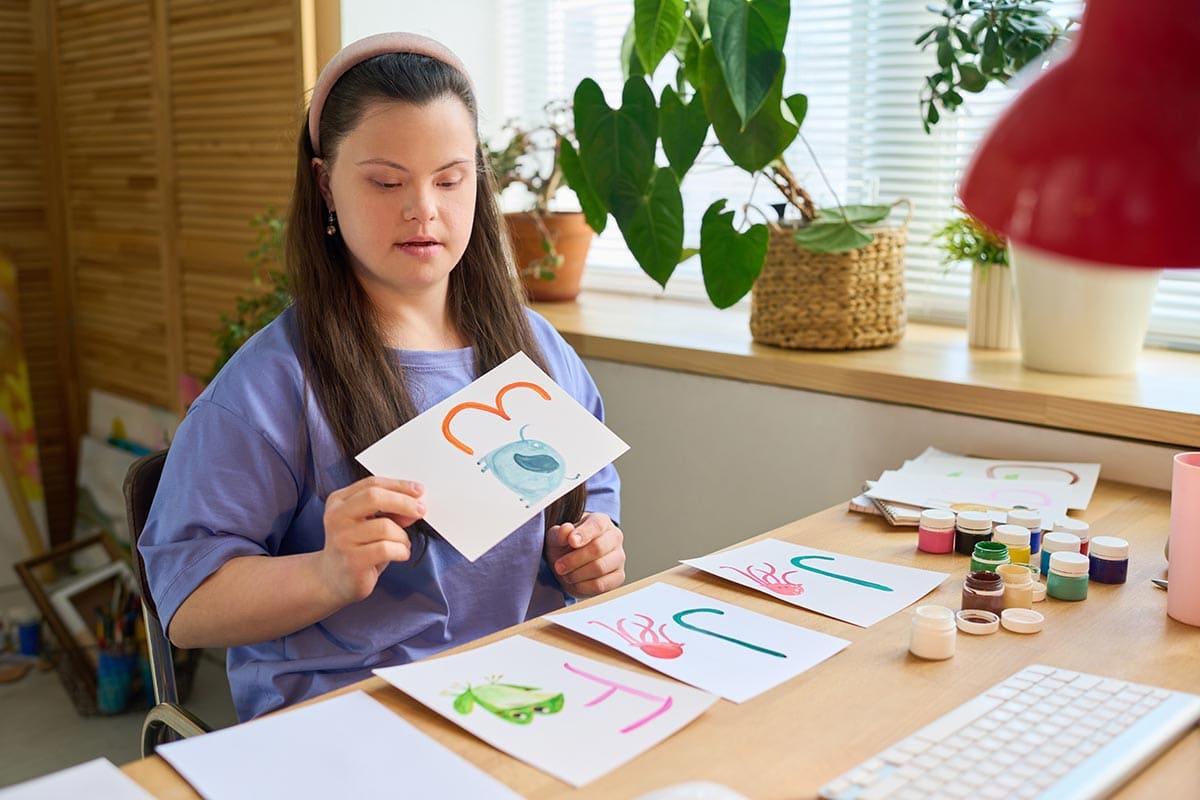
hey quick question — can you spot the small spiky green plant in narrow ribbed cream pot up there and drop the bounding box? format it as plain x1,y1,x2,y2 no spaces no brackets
934,207,1018,350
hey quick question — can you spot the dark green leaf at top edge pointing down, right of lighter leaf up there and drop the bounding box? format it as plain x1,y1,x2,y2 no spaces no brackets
706,0,791,126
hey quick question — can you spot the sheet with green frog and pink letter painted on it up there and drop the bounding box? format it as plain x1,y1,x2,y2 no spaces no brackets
374,636,718,787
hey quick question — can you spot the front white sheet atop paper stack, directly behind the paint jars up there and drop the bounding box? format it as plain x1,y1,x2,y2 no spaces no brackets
865,470,1072,523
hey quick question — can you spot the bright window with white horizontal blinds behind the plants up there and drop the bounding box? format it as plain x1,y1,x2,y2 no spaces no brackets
500,0,1200,349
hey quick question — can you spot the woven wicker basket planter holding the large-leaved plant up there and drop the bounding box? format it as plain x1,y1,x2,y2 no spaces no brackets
750,223,908,350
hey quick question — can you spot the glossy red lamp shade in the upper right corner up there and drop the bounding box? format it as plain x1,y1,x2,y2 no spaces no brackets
959,0,1200,267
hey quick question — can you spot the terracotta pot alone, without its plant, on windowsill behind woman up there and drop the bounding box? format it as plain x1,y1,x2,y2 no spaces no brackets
504,211,595,301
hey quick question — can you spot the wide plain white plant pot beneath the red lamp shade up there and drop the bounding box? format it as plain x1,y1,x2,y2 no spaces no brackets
1008,242,1162,375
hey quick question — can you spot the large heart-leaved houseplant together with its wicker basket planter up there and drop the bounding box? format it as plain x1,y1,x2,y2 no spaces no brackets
562,0,905,349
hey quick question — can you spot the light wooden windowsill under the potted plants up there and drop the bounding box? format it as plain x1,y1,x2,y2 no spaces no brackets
533,290,1200,449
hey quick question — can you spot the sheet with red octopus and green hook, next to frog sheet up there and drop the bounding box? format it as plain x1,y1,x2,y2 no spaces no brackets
547,583,850,703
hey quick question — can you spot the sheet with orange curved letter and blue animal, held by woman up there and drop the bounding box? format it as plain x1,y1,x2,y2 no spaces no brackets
358,353,629,561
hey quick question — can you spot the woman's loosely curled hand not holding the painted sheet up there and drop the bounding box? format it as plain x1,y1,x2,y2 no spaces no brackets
546,511,625,597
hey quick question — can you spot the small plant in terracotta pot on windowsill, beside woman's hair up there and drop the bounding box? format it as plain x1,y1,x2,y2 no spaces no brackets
484,101,595,301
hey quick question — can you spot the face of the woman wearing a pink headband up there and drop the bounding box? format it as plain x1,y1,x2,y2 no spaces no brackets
313,95,476,309
